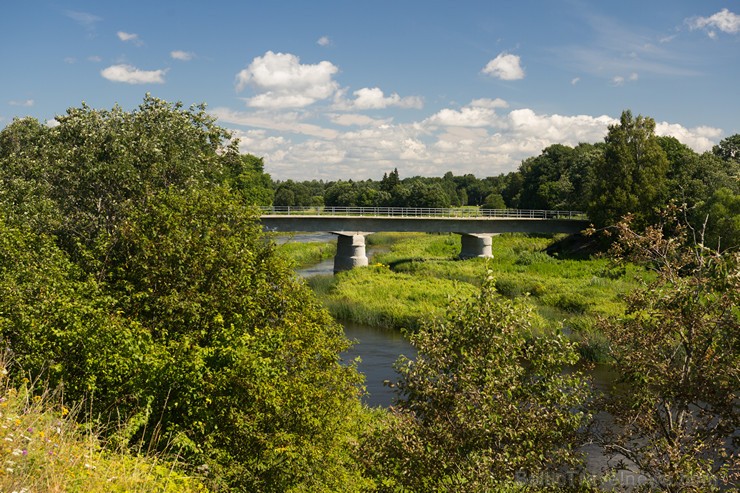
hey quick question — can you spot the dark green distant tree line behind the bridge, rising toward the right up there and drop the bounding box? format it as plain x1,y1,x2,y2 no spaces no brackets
273,111,740,247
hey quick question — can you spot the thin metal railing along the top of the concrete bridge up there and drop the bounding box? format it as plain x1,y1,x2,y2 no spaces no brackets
260,206,588,220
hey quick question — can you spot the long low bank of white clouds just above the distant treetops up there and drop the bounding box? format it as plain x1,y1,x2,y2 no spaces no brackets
211,96,722,180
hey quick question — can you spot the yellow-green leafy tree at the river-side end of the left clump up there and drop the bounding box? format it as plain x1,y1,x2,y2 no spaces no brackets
102,189,370,491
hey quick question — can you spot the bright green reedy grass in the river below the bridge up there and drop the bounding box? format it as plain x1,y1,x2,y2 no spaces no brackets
309,233,649,360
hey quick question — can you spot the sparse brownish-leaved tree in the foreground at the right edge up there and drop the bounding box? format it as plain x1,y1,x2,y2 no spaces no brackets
600,210,740,492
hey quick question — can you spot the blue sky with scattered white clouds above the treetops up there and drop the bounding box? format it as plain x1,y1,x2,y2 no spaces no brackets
0,0,740,180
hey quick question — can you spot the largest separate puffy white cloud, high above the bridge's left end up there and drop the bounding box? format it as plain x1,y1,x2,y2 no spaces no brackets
236,51,339,108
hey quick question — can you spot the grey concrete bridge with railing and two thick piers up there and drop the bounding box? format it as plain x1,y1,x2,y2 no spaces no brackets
261,207,589,273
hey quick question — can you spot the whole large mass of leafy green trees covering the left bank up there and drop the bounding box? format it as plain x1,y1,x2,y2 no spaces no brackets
0,96,364,491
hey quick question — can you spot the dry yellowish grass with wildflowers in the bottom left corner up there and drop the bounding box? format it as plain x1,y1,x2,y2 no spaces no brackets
0,363,207,493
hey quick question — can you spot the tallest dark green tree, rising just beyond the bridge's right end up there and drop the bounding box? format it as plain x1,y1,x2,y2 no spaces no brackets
588,110,668,227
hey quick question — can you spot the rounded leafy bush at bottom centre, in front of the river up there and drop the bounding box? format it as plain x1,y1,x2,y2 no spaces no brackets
364,277,588,491
